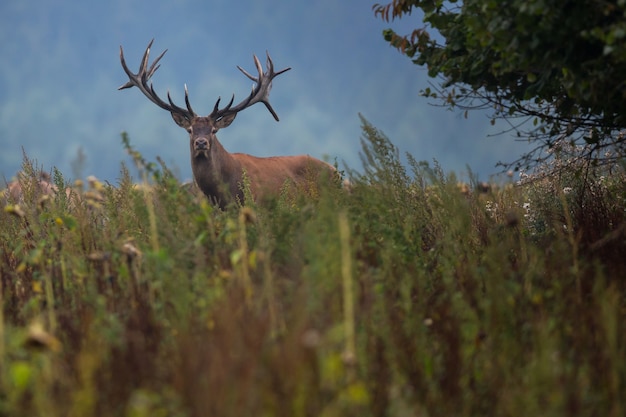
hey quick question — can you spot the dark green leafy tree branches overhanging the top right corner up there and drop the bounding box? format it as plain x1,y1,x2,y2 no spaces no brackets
373,0,626,167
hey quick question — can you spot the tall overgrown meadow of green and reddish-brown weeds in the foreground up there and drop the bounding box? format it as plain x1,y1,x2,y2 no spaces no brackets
0,121,626,417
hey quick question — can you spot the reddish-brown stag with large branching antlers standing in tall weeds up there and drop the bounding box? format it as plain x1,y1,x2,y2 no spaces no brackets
118,39,338,209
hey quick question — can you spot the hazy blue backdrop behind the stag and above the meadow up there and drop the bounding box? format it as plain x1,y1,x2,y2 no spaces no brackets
0,0,525,182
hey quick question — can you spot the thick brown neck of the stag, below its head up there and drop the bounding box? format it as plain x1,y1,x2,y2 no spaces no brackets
191,140,243,208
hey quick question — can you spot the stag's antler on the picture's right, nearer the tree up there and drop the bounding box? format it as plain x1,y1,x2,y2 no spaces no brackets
209,52,291,121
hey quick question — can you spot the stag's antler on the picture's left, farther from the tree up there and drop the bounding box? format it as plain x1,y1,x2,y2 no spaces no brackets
118,39,196,120
